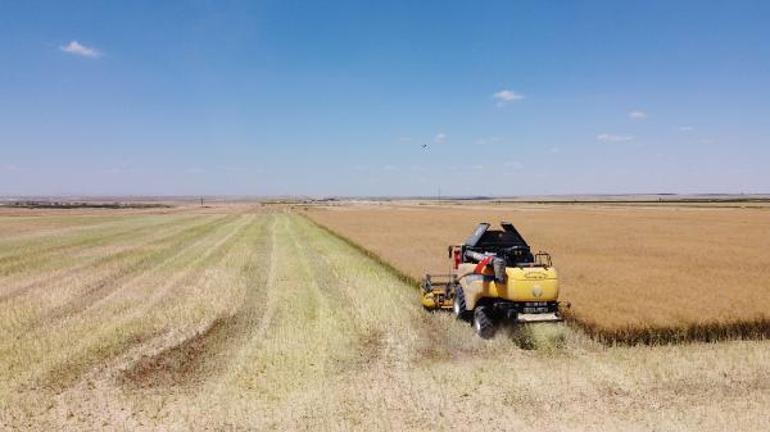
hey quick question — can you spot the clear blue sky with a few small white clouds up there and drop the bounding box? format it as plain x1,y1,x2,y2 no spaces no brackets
0,0,770,196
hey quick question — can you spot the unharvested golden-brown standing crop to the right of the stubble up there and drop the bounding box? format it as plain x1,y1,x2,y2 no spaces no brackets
306,204,770,343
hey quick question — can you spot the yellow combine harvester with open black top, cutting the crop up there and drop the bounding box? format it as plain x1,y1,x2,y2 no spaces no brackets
422,222,568,338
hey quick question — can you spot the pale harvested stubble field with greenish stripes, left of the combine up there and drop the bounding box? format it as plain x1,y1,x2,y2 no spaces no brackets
0,206,770,431
